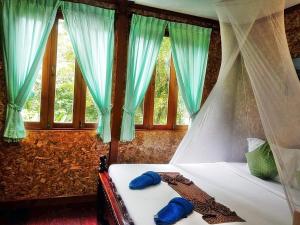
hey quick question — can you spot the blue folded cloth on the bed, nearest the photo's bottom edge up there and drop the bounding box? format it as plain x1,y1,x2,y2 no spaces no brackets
154,197,194,225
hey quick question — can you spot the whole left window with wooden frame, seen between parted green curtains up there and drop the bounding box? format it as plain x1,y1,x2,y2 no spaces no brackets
23,15,98,129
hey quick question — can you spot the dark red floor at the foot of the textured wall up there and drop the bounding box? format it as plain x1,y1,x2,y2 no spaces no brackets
0,205,99,225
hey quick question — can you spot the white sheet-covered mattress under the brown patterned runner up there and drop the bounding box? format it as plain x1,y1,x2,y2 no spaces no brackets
109,162,292,225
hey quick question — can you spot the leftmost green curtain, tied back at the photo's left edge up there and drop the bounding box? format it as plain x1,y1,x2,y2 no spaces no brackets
0,0,59,141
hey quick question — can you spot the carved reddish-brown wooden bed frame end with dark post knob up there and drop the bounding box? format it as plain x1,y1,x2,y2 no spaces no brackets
97,156,134,225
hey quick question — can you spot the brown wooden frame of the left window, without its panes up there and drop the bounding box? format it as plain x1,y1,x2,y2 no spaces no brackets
25,11,97,130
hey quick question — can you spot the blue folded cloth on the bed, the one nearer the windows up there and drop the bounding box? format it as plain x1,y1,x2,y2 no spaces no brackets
129,171,161,190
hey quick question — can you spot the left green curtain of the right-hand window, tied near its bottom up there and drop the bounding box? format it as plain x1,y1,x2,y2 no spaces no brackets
120,15,167,141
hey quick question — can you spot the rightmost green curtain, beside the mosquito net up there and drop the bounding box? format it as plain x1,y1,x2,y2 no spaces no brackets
169,22,211,119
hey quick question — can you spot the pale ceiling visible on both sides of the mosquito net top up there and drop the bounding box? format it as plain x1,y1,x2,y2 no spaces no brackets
134,0,300,20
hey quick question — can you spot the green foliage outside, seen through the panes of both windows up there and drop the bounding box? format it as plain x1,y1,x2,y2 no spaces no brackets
23,20,189,125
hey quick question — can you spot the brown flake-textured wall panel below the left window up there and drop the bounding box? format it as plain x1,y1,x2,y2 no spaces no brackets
0,131,108,201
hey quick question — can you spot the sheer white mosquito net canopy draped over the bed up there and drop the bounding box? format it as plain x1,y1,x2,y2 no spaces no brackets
170,0,300,216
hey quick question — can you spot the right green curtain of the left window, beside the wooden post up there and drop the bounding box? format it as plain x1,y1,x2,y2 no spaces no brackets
62,2,115,143
